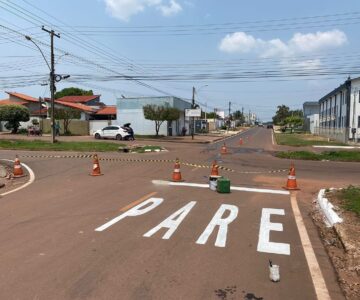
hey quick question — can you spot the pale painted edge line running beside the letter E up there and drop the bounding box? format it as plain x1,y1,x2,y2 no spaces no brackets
290,193,331,300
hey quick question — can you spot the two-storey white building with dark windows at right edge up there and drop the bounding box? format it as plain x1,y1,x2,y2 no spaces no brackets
318,77,360,142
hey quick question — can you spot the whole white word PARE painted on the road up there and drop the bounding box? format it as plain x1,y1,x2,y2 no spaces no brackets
95,197,290,255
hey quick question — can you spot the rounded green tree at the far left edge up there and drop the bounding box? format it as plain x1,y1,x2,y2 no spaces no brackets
0,104,30,133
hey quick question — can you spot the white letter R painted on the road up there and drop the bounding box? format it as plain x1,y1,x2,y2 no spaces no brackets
196,204,238,247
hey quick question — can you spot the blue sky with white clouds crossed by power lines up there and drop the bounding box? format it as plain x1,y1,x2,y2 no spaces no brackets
0,0,360,121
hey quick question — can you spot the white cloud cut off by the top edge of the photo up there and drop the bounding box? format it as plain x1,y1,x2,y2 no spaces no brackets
104,0,182,21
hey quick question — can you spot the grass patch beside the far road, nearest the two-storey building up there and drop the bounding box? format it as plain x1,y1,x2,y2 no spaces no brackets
275,133,345,147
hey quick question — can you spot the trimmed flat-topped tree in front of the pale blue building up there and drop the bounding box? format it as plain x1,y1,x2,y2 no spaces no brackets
143,104,180,136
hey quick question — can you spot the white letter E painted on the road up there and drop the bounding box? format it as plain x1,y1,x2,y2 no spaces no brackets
257,208,290,255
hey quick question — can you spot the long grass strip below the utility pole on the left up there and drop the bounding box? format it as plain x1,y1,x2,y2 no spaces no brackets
0,140,124,152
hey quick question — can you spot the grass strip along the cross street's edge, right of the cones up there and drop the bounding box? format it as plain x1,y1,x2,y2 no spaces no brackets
276,151,360,162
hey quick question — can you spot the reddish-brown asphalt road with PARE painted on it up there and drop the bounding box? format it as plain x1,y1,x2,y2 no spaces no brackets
0,128,358,299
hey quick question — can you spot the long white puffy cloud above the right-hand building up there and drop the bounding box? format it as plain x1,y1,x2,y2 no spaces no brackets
219,30,347,57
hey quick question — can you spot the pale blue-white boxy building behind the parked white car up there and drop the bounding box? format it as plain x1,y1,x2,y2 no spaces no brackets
116,96,191,135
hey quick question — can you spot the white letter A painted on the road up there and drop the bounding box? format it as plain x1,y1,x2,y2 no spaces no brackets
144,201,196,239
